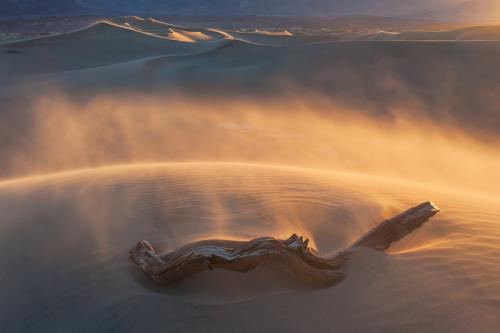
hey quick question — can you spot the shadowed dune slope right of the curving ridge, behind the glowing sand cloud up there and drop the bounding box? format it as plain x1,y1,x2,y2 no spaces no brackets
134,41,500,131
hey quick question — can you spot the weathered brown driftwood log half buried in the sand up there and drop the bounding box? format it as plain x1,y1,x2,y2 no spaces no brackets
129,202,439,285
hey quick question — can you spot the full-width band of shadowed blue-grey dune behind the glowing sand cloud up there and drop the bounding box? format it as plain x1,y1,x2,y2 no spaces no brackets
0,33,500,137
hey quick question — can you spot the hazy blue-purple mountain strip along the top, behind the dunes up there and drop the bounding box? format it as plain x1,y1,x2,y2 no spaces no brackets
0,0,500,20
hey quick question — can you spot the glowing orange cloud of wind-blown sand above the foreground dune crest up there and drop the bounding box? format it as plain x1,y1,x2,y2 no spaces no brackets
3,94,500,197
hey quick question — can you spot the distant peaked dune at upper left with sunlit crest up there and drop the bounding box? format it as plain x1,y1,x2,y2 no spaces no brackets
0,21,232,76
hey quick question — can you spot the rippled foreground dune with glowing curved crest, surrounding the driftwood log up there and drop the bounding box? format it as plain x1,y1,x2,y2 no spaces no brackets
0,163,500,332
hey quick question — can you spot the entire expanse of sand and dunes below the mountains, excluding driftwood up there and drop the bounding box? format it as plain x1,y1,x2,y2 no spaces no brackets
0,16,500,333
